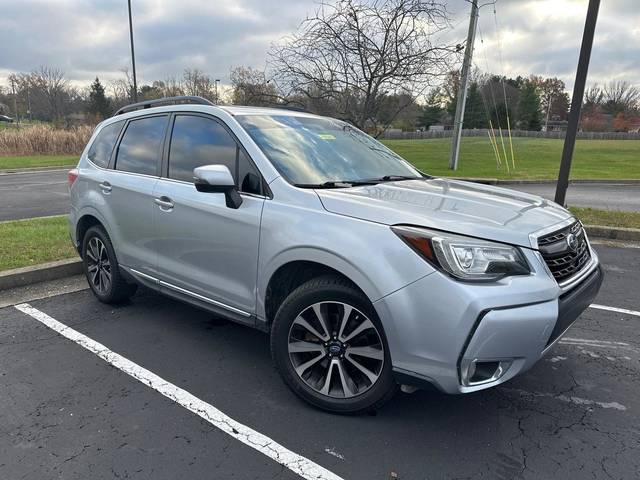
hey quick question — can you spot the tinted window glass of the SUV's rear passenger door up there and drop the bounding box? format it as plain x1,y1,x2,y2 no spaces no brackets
116,116,167,175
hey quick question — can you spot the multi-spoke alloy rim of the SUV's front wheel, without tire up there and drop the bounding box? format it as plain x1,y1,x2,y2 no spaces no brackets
288,302,385,398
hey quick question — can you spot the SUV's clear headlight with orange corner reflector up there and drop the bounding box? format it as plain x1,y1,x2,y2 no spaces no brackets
391,226,531,281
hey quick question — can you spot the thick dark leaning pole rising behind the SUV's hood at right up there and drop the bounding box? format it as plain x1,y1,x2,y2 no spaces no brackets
555,0,600,205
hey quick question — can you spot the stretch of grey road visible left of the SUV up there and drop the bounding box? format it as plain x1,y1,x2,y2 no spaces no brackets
0,170,69,221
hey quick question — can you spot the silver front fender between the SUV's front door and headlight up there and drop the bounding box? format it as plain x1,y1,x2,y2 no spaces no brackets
257,178,434,321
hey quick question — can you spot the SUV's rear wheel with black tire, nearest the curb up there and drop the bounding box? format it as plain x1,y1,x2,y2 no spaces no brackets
82,225,137,304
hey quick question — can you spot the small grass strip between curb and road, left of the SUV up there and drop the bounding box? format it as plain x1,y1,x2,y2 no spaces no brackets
0,215,78,270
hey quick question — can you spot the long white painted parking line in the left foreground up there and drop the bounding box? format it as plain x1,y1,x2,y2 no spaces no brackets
15,303,342,480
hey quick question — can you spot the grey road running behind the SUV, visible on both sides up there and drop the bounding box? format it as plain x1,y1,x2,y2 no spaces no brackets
0,170,640,221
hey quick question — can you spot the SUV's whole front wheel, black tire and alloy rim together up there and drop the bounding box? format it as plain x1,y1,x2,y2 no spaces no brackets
271,275,397,414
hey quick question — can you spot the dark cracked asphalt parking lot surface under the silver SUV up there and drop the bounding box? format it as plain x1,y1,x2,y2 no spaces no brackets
0,245,640,480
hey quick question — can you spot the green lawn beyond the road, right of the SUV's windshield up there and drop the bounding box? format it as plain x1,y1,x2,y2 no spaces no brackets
384,137,640,179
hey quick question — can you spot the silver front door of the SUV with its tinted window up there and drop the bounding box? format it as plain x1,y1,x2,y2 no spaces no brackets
154,114,266,319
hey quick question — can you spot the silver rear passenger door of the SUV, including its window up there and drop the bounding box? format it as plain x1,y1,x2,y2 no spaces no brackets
99,115,169,275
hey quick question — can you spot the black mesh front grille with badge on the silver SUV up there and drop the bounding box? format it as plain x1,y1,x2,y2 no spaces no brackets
538,222,591,283
